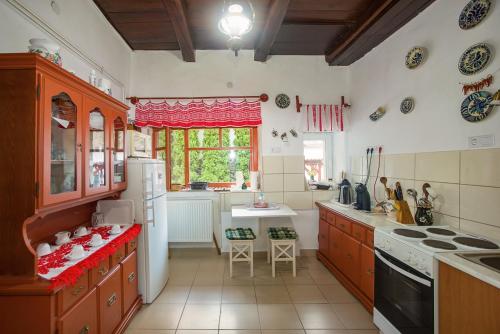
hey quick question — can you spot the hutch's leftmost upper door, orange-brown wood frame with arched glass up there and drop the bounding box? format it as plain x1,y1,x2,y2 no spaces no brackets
42,76,83,207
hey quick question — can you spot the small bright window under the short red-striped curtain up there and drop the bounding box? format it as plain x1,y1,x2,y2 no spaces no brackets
303,134,332,182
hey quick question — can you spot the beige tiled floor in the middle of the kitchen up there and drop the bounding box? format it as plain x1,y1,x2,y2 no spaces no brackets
126,249,378,334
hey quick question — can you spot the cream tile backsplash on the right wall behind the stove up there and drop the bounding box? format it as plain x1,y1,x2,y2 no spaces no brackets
350,148,500,240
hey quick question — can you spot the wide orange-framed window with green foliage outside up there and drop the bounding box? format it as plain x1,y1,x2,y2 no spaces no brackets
154,127,258,189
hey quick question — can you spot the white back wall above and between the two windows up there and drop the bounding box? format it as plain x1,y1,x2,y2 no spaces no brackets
131,50,349,155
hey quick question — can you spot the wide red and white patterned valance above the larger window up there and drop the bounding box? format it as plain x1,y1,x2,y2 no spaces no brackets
135,100,262,129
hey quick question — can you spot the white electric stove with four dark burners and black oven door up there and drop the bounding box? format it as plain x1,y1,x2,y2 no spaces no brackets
373,225,500,334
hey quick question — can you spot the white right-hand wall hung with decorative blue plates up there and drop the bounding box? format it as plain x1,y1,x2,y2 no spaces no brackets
347,0,500,156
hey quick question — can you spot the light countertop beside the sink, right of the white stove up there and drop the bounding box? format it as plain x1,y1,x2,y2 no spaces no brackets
435,251,500,289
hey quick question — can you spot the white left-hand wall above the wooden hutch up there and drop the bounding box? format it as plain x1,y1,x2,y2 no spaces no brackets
0,0,131,99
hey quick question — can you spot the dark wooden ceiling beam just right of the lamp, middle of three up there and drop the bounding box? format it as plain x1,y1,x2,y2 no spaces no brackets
254,0,290,61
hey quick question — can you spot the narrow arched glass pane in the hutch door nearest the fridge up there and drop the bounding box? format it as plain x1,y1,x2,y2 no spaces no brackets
111,117,126,188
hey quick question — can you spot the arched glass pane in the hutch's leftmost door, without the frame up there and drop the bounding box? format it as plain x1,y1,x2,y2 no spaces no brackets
50,93,78,195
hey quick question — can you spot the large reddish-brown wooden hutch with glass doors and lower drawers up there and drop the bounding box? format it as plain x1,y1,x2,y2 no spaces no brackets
0,54,142,334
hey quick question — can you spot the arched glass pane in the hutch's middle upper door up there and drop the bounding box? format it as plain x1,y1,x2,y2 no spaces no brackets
87,108,107,190
